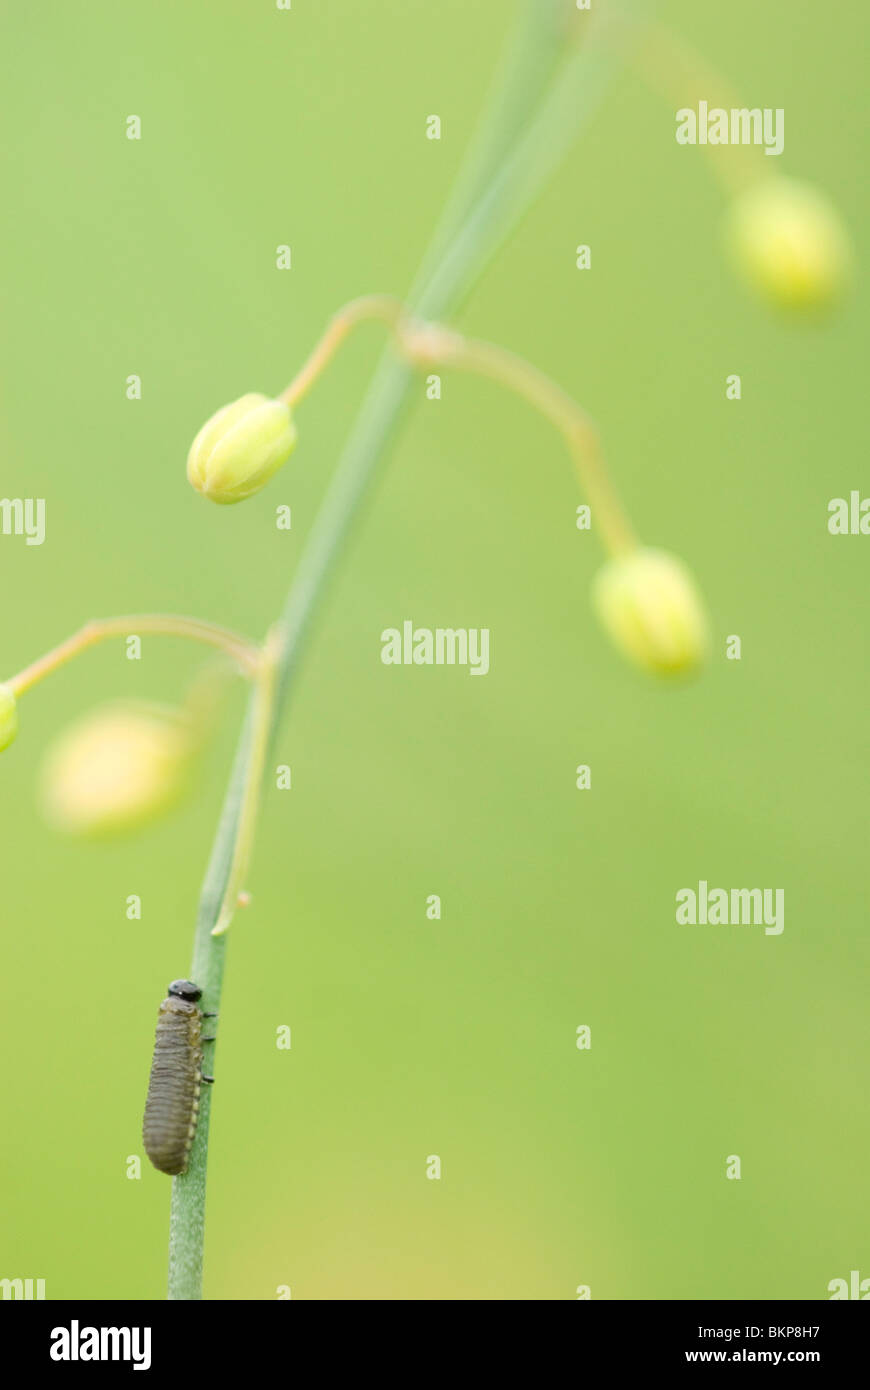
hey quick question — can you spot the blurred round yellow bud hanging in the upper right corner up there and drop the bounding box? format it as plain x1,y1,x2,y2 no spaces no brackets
727,175,852,310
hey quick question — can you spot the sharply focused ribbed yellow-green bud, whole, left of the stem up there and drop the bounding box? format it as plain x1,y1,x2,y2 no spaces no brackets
188,392,296,503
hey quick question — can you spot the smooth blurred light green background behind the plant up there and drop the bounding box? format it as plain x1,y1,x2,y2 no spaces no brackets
0,0,870,1300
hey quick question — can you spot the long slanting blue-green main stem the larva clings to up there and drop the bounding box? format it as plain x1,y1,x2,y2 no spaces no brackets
168,0,639,1300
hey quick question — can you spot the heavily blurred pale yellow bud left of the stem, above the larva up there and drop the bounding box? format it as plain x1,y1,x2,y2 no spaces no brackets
40,701,196,835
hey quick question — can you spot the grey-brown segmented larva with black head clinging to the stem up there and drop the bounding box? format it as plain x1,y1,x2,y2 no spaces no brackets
142,980,209,1175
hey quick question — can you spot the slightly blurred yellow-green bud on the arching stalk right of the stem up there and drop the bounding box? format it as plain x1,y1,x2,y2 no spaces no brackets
592,550,707,676
